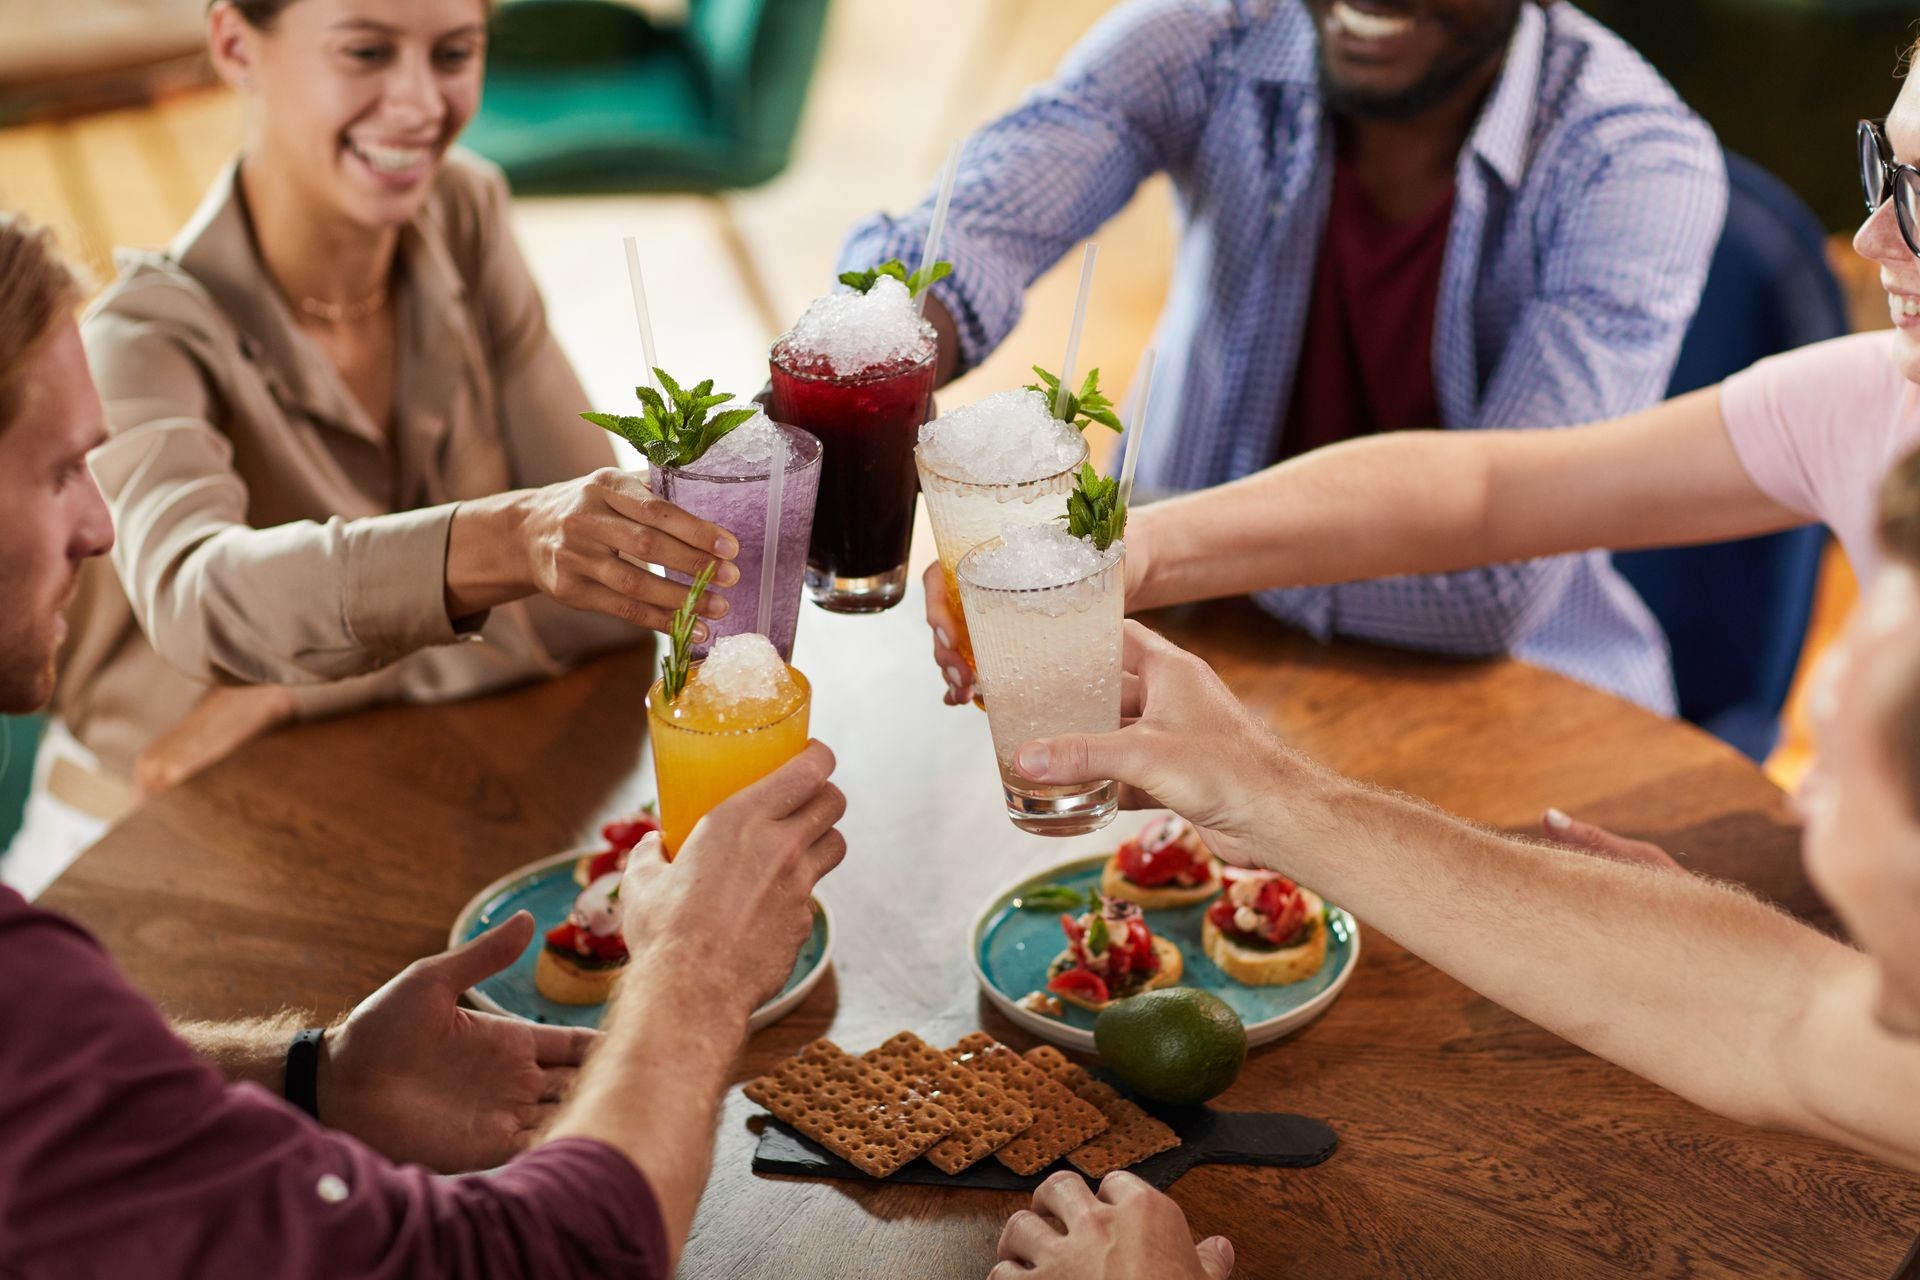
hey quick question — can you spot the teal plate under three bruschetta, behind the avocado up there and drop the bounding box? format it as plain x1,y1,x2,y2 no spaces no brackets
970,854,1359,1054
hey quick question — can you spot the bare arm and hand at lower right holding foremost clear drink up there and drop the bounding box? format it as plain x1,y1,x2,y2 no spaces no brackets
1020,624,1920,1169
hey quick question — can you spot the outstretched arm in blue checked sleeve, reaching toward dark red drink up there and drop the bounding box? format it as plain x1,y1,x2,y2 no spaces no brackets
839,0,1238,382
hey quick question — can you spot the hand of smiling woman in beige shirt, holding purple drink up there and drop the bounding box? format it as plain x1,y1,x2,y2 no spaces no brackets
447,466,739,639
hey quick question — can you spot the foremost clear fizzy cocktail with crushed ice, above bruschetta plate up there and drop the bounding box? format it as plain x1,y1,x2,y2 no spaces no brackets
958,524,1127,835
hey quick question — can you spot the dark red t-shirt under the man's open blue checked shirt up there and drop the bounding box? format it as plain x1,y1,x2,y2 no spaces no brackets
1279,155,1453,459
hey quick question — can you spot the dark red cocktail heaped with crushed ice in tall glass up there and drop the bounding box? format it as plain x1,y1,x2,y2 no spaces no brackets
768,278,935,614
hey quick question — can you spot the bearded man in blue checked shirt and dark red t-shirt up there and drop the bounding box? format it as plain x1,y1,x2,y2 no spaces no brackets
856,0,1726,712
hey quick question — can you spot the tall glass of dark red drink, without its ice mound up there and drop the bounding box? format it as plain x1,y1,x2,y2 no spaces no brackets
768,338,935,614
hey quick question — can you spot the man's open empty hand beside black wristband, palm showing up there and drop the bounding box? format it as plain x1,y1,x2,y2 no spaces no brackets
319,912,599,1173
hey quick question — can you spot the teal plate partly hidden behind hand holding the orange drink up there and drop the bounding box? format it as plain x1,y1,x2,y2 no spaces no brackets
458,844,833,1031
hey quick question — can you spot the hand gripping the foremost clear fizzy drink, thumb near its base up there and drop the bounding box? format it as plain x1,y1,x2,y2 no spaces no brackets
1016,622,1352,867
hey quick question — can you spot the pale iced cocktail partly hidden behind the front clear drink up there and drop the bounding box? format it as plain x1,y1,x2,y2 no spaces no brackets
914,390,1087,668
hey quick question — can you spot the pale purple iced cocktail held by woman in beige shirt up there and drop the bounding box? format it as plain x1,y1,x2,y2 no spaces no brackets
655,413,822,658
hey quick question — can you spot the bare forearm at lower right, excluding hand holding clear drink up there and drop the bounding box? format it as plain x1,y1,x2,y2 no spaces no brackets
1263,771,1920,1169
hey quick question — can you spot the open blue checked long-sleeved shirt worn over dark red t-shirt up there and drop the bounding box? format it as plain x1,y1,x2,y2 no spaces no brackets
841,0,1726,712
